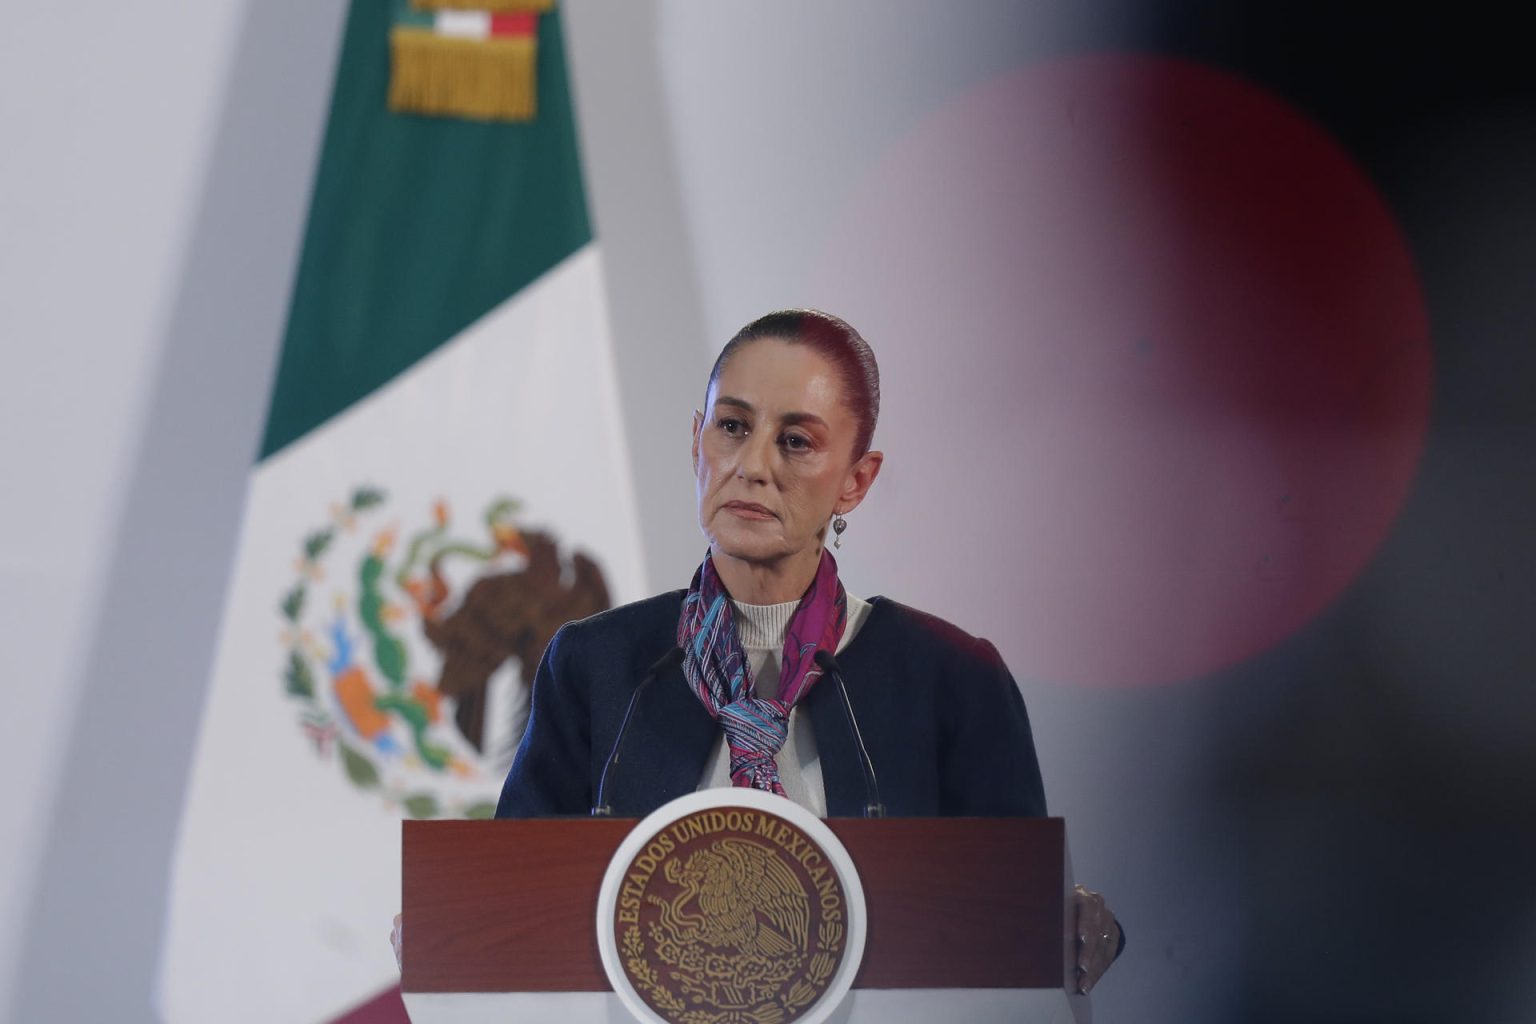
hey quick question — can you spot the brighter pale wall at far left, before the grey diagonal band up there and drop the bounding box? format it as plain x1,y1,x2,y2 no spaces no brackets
0,3,240,1004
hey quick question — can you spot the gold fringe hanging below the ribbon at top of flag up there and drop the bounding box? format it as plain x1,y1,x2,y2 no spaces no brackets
389,26,538,121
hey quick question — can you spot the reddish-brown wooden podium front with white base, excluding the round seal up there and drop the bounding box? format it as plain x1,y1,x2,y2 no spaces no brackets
401,818,1091,1024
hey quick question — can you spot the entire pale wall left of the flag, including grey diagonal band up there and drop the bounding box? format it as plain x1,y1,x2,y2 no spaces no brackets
0,0,343,1021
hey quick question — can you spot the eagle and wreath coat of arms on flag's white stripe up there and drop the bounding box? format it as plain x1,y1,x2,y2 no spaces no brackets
278,487,608,818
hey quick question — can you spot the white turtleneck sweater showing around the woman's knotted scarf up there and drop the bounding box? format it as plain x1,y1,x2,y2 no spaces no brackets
699,594,871,818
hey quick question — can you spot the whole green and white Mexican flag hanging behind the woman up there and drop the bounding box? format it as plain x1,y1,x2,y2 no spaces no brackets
160,0,644,1024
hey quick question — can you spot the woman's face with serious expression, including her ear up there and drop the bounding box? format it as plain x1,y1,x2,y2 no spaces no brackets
693,338,882,573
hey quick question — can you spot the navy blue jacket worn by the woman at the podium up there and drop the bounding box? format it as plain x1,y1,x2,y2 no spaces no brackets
496,591,1046,818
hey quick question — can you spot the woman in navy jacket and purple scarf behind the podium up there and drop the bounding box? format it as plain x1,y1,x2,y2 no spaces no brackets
496,310,1123,992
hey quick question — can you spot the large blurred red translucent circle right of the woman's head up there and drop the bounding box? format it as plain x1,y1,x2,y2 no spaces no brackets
816,55,1432,685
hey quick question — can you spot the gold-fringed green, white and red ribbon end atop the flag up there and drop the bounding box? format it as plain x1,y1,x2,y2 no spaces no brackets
389,0,554,121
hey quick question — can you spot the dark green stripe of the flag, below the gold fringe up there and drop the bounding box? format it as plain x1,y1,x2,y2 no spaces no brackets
261,0,591,459
